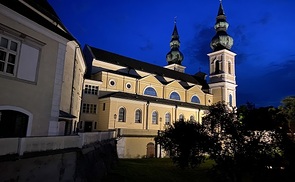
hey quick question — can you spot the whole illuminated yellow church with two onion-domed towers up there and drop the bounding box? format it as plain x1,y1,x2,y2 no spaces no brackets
78,3,237,158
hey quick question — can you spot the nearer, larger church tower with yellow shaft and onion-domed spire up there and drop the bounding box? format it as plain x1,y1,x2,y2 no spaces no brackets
207,1,237,107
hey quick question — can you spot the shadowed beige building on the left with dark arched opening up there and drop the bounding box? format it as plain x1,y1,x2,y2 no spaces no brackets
0,0,86,137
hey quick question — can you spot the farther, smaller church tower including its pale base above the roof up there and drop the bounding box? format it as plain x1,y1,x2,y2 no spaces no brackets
165,20,185,73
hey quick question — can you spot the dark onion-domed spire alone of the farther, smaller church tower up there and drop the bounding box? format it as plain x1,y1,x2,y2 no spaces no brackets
166,17,183,65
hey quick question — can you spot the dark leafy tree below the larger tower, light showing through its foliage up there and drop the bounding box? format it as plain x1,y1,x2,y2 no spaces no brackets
203,102,282,181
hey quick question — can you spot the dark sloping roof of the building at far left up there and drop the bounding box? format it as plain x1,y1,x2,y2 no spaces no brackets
0,0,77,41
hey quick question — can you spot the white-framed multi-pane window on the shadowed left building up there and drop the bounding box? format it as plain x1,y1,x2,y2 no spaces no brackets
0,35,20,76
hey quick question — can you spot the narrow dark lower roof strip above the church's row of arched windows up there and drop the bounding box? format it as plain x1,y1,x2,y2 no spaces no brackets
99,92,208,109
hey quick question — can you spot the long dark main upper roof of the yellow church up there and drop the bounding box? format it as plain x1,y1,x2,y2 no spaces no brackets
84,45,209,92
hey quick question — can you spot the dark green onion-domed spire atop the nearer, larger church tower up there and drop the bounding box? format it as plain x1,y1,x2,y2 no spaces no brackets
210,0,233,51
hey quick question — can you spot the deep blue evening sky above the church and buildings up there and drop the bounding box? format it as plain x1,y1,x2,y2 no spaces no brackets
48,0,295,107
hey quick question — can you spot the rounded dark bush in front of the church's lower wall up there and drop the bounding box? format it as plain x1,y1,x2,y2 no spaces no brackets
155,120,207,168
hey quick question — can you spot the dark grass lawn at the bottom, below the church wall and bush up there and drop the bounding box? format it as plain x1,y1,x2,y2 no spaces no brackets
103,158,213,182
